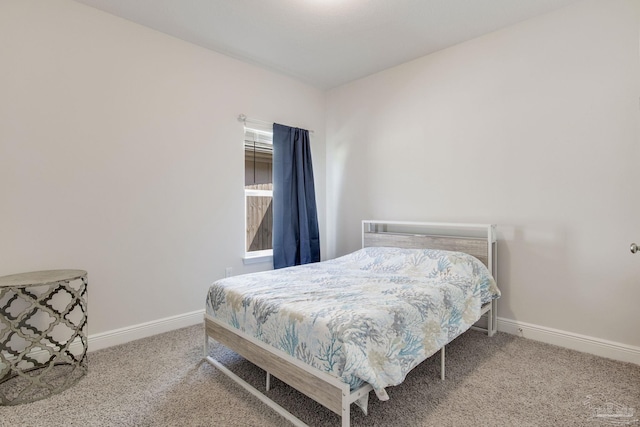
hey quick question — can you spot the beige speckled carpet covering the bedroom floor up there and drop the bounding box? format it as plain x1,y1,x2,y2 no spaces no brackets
0,326,640,427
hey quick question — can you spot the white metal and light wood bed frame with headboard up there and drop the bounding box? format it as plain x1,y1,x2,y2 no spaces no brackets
204,220,497,427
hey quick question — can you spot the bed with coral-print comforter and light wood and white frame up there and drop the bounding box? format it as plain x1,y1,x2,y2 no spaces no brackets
204,220,500,427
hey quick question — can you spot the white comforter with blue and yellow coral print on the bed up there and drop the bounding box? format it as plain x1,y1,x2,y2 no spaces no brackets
206,247,500,400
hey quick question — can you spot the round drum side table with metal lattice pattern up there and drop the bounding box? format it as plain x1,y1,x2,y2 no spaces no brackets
0,270,87,405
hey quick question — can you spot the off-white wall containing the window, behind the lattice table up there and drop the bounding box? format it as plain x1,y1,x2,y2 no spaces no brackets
0,0,326,340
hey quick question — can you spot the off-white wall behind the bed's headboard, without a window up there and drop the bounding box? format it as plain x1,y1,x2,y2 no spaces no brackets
327,0,640,346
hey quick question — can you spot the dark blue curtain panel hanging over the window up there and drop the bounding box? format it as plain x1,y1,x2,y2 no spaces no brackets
273,123,320,268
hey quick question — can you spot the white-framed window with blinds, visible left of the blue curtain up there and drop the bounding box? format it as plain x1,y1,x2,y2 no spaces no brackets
244,127,273,260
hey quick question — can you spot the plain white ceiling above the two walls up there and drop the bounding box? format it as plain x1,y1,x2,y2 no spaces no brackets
76,0,581,89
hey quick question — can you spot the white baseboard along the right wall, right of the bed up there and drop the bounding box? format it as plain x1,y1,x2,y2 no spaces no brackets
498,317,640,365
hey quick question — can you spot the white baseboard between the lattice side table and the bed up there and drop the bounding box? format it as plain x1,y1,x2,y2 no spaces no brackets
89,310,204,352
